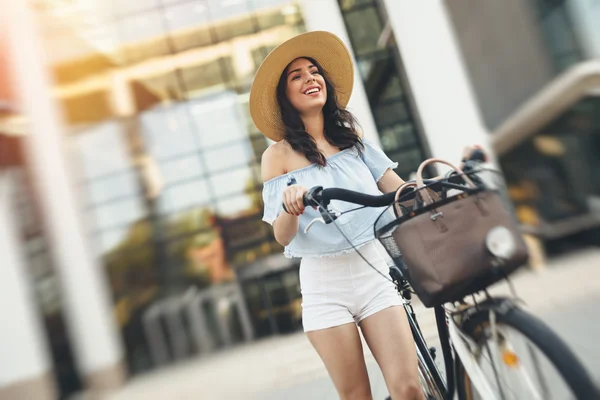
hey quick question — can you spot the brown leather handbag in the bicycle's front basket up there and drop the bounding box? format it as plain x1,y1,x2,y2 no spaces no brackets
380,158,528,307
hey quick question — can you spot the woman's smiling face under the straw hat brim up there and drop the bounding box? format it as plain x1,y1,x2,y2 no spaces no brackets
284,58,327,115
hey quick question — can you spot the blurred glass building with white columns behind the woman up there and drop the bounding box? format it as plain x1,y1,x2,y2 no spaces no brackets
0,0,600,398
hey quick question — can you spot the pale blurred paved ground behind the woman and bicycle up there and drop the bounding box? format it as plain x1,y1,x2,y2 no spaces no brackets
106,249,600,400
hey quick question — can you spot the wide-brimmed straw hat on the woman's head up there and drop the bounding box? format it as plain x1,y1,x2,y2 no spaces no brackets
250,31,354,142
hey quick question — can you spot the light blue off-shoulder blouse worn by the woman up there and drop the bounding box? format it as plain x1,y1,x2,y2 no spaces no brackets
263,139,398,258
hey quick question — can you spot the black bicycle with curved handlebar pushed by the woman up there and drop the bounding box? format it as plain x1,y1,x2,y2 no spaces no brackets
292,160,600,400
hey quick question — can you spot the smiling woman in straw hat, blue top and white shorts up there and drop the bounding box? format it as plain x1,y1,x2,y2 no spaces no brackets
250,32,478,400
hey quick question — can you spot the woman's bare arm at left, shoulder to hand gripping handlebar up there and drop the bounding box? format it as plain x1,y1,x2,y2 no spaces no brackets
261,145,306,246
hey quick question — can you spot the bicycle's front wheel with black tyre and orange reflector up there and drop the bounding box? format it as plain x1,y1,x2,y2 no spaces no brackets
456,307,600,400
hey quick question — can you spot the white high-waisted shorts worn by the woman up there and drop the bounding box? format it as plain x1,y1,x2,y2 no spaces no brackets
300,241,402,332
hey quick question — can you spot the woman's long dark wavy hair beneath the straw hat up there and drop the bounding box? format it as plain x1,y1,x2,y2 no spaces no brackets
277,57,364,166
